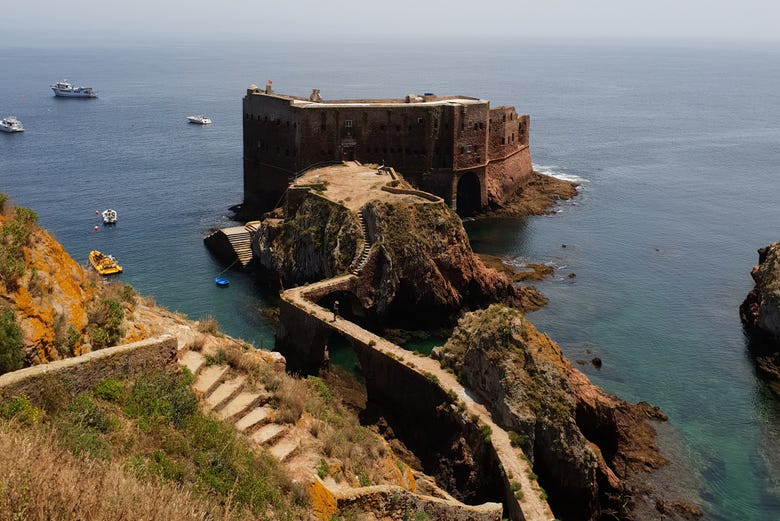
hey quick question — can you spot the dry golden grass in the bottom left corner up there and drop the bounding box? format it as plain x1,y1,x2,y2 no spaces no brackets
0,422,252,520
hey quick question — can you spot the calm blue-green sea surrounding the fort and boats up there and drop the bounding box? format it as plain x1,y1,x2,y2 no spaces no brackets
0,37,780,520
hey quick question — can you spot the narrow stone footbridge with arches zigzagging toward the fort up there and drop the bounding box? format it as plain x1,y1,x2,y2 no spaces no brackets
276,275,555,521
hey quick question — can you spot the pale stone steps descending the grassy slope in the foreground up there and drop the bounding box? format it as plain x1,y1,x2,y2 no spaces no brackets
179,351,299,463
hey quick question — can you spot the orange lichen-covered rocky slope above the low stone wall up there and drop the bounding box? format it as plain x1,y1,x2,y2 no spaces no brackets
0,199,204,365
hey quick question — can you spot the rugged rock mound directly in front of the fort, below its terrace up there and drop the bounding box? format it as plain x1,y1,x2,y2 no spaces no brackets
253,186,545,328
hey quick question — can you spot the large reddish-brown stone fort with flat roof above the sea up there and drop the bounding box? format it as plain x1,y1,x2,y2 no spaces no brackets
241,81,532,218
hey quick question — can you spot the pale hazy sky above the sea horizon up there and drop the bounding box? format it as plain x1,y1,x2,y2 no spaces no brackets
6,0,780,40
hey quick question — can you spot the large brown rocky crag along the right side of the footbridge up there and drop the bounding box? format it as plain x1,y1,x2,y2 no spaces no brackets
433,305,697,520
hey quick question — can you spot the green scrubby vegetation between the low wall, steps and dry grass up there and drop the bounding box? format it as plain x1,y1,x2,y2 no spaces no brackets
0,371,306,519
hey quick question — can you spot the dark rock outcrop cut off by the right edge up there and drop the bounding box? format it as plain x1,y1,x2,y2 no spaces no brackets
739,242,780,395
